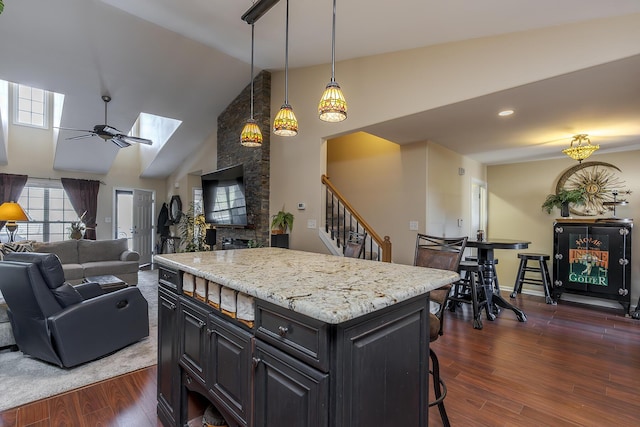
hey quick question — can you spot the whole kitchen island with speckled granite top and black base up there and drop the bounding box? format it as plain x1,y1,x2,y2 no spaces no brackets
155,248,458,427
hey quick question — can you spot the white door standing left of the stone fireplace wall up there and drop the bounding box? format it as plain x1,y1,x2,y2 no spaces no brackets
131,190,154,265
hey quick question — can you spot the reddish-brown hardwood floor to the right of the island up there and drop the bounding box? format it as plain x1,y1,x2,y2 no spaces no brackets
429,291,640,427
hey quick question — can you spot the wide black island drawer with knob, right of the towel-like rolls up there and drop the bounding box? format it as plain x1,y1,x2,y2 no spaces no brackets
256,301,329,372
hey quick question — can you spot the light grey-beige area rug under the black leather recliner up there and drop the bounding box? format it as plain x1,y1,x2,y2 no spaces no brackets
0,270,158,411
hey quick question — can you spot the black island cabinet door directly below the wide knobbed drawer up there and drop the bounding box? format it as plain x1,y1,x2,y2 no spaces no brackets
253,340,329,427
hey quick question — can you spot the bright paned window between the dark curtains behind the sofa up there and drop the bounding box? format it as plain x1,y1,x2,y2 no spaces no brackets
16,181,78,242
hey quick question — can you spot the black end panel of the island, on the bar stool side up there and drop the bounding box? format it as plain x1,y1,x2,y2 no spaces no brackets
335,298,430,427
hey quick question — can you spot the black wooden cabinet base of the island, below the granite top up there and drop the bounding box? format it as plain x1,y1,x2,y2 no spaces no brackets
158,269,429,427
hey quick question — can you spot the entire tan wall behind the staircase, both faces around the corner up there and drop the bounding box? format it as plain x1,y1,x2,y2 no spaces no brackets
327,132,485,264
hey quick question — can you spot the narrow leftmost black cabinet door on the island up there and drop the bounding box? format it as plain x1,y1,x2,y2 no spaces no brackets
158,286,180,425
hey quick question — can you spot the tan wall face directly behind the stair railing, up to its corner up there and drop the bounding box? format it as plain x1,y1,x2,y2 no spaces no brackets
327,132,427,264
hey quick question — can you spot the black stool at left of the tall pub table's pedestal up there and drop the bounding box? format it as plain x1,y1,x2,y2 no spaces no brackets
449,260,487,329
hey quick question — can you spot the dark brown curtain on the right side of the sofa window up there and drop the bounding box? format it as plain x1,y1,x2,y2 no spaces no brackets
60,178,100,240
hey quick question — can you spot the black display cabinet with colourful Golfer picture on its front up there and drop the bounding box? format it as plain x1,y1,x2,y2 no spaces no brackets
553,219,633,314
